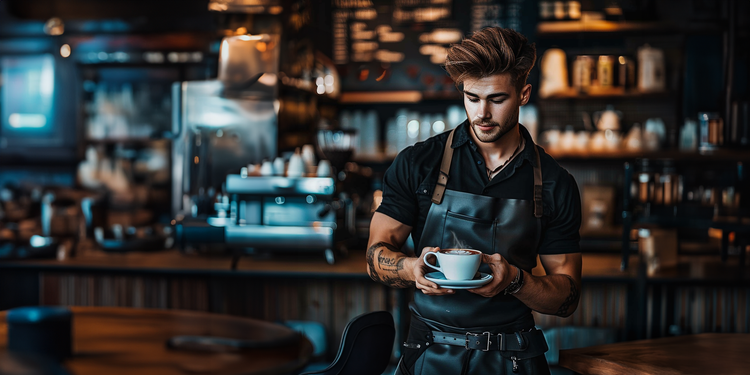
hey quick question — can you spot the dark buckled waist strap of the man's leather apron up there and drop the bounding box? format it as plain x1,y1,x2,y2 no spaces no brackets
432,328,544,352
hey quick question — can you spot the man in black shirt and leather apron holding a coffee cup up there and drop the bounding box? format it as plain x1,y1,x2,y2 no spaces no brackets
367,28,581,374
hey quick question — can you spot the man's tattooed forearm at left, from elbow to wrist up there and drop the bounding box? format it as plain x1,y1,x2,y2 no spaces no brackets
367,241,416,288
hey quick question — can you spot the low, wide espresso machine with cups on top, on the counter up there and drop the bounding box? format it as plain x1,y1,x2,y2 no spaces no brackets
176,174,343,264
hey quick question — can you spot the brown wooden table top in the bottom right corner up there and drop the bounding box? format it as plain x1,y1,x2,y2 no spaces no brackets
559,333,750,375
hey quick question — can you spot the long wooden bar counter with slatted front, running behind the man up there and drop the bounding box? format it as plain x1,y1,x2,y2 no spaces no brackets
0,249,750,347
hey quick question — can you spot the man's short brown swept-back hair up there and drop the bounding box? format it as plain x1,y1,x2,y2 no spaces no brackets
445,27,536,91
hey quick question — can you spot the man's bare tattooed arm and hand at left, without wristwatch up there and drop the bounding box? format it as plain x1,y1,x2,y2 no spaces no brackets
367,212,453,295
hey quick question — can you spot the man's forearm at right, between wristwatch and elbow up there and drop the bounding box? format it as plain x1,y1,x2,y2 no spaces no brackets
514,272,581,317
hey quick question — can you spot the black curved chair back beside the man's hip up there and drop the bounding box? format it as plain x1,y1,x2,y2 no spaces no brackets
300,311,396,375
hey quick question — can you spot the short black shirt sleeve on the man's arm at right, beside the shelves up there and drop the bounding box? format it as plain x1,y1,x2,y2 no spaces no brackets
539,169,581,255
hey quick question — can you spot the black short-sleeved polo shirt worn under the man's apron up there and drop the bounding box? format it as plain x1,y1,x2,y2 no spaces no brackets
377,120,581,254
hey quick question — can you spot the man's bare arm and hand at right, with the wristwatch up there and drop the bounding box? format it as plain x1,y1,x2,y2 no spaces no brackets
470,253,581,316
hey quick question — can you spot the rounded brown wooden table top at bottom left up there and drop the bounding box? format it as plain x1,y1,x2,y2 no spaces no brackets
0,307,313,375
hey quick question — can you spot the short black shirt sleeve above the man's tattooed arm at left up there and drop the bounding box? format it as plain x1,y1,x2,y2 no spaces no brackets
376,147,419,227
